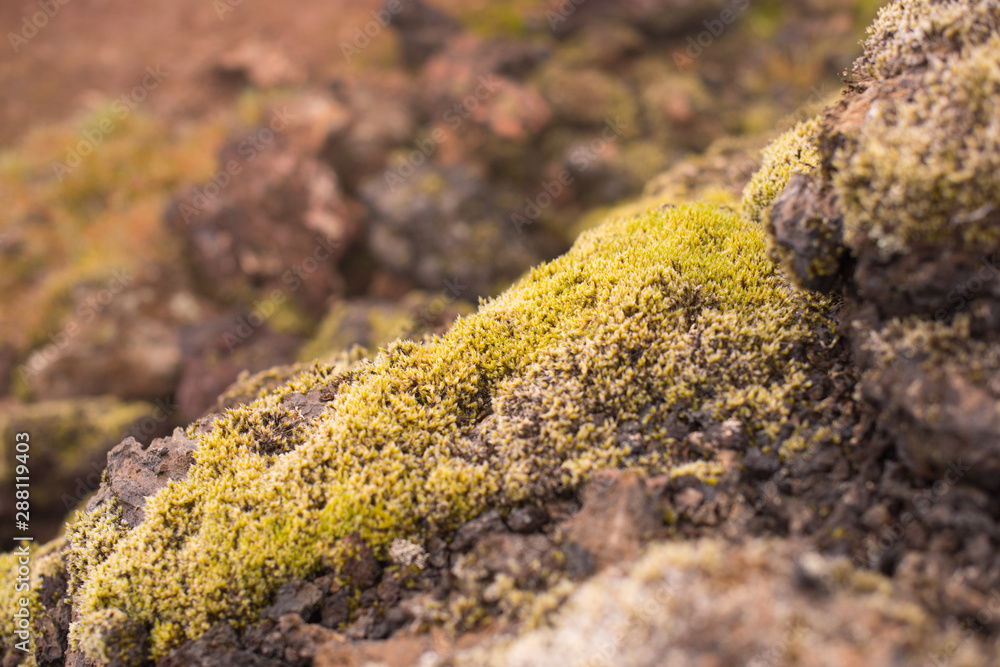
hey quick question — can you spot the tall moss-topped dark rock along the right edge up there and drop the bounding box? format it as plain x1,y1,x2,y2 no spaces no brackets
745,0,1000,656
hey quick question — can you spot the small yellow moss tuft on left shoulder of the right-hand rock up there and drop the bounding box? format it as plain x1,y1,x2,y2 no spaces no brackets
743,118,820,224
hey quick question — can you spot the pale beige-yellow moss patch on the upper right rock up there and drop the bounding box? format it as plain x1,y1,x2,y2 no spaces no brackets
833,32,1000,254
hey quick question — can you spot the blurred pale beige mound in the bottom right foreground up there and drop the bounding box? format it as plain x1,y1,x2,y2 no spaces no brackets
451,540,993,667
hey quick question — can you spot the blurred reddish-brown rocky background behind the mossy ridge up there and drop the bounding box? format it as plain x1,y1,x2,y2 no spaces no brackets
0,0,881,539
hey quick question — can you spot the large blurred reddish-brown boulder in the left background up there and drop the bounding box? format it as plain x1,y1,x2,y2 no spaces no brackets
165,134,357,318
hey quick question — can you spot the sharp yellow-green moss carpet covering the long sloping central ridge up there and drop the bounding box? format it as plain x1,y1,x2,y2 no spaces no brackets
62,204,835,662
